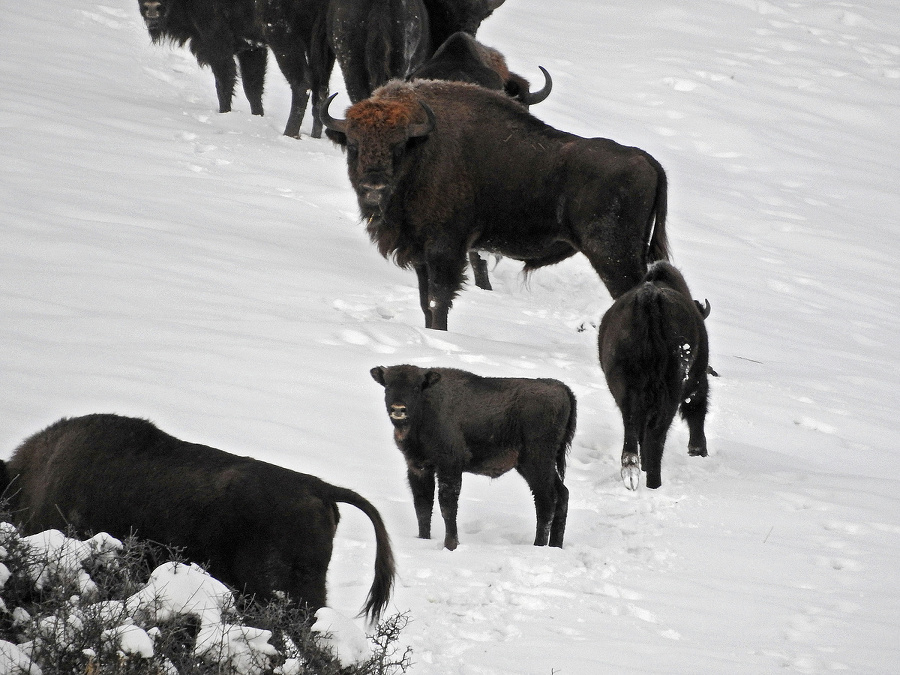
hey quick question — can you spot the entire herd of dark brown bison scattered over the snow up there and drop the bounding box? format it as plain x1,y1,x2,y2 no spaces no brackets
0,0,709,620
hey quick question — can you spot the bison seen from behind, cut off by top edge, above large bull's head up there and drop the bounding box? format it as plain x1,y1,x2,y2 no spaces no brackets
325,0,432,103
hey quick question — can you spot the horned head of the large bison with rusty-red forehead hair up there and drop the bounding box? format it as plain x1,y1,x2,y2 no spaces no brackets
321,88,437,218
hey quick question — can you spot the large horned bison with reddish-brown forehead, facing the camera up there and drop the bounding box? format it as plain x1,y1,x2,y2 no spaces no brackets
322,80,668,330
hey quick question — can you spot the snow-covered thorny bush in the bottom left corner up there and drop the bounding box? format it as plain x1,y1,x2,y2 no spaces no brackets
0,522,409,675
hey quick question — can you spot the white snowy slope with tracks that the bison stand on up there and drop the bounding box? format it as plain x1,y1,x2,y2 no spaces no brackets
0,0,900,675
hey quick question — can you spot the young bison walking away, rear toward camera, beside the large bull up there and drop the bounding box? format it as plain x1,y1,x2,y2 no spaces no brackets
598,262,709,490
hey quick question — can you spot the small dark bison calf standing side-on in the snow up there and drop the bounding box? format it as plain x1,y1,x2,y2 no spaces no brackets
370,365,576,551
